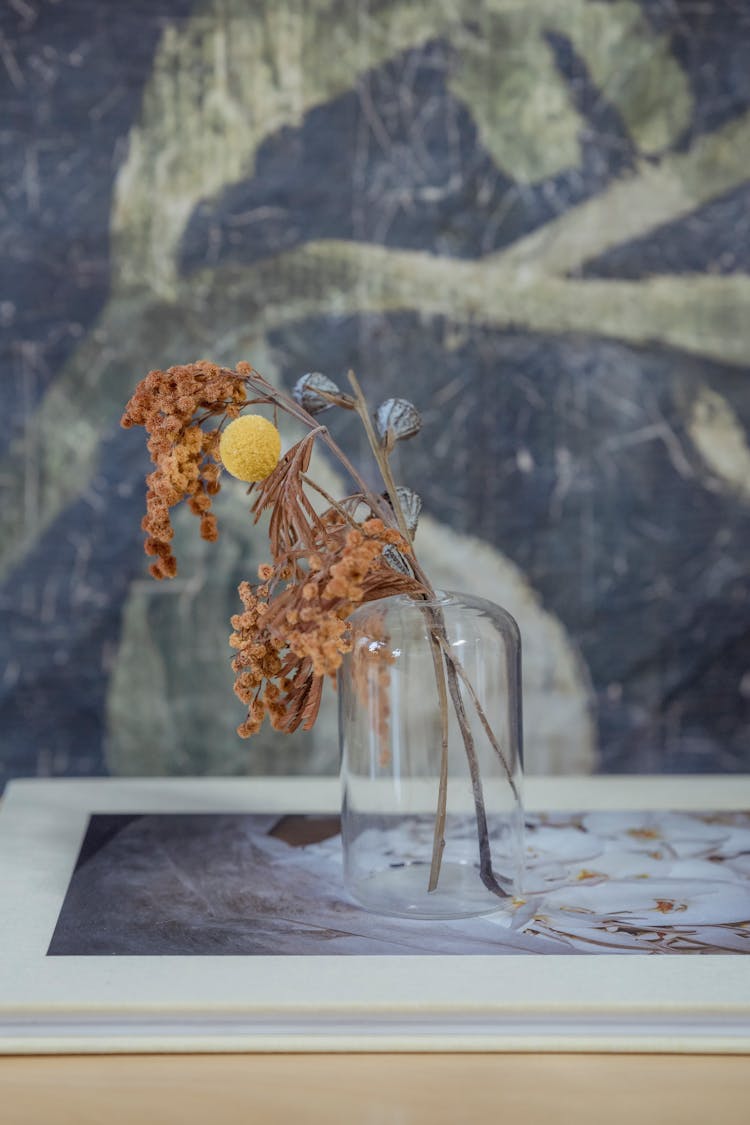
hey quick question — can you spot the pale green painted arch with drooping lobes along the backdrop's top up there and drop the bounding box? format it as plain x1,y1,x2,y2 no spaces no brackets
111,0,690,281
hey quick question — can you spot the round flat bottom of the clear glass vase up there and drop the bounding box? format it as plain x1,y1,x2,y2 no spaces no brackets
346,862,513,920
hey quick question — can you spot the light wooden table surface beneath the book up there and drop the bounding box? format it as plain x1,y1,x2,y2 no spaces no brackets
0,1054,750,1125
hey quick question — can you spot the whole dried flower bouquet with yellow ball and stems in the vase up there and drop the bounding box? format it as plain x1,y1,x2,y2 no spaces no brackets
121,361,517,897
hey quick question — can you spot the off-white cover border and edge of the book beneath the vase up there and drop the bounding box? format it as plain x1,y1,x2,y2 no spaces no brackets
0,776,750,1053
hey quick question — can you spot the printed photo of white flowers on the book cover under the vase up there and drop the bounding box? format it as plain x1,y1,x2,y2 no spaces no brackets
48,811,750,956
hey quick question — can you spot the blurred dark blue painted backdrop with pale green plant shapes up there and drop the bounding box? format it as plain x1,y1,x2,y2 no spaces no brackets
0,0,750,792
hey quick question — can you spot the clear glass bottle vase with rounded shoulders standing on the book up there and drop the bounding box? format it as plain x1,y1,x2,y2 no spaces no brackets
338,593,523,918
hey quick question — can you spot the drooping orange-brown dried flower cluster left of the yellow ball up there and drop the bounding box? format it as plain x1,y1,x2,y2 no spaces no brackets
121,360,246,578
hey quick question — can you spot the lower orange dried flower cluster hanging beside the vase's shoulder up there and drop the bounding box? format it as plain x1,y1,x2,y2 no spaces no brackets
229,510,418,738
